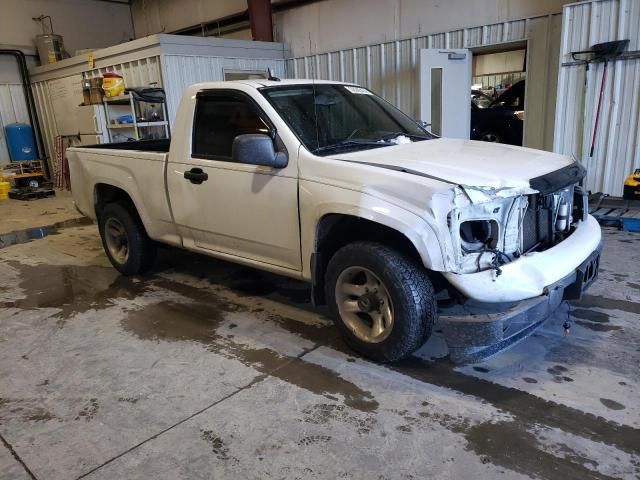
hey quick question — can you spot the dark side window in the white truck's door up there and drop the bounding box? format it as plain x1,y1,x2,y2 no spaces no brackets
192,94,271,160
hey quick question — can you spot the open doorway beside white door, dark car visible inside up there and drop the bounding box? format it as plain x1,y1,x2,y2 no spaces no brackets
470,43,527,145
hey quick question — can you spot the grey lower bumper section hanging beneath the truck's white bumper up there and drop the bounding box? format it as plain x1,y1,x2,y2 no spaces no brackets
438,243,602,363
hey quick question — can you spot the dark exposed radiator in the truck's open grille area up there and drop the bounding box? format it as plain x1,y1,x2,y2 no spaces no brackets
522,194,553,252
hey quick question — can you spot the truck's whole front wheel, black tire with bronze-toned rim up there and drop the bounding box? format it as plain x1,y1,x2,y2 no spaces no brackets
325,242,437,362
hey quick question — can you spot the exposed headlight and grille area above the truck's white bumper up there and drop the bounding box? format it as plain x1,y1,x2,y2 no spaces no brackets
447,161,588,277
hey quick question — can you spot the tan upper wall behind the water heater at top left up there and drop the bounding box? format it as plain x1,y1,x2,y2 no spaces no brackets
0,0,133,55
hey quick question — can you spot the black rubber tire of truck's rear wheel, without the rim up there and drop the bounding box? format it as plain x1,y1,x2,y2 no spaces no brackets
98,203,157,275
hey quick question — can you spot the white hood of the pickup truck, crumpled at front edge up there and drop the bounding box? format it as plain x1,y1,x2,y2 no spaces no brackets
330,138,573,192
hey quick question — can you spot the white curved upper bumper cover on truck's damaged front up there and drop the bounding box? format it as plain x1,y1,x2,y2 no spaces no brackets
443,215,602,303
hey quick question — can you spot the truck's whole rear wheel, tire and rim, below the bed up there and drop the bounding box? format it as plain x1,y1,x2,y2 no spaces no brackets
98,203,156,275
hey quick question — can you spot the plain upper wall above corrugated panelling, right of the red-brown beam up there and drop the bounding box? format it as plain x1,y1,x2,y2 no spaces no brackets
276,0,570,57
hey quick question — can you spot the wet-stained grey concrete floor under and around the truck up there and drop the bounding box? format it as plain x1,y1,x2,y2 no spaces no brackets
0,193,640,480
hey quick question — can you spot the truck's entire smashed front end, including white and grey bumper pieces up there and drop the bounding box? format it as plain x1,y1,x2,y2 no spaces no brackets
440,162,601,363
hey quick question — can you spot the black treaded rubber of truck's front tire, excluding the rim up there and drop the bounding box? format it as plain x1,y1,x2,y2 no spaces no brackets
325,242,438,362
